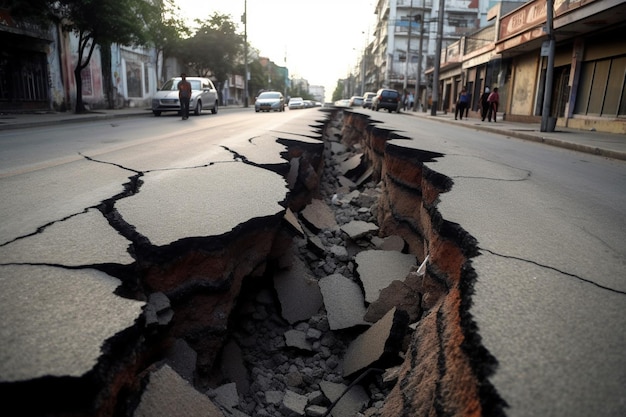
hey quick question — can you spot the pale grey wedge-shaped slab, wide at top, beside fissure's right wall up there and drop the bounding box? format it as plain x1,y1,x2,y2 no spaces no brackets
355,250,416,303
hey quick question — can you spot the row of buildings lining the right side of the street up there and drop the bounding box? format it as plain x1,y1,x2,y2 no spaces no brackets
356,0,626,133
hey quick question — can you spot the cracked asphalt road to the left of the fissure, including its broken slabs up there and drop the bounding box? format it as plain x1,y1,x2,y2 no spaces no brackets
0,110,324,382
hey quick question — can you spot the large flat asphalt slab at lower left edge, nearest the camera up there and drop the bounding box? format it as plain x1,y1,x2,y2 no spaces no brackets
0,265,145,383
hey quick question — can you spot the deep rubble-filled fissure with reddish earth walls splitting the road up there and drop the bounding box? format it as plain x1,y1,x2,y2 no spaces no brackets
2,110,505,417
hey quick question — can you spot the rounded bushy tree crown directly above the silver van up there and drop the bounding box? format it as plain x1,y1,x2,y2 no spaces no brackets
181,13,243,86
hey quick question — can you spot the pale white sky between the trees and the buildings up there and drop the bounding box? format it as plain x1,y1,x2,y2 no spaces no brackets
174,0,376,101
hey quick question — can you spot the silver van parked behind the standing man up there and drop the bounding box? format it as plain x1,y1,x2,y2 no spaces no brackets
152,77,218,116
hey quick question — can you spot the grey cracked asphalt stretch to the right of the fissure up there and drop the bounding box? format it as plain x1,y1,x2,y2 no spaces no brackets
354,112,626,417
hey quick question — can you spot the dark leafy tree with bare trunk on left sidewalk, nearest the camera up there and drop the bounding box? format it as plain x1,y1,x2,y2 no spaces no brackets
8,0,155,113
